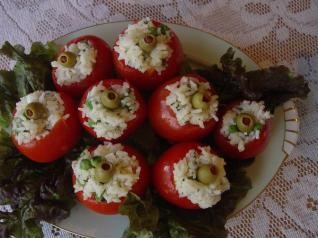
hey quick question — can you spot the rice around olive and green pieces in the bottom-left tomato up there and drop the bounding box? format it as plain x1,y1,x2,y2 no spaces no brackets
72,143,141,203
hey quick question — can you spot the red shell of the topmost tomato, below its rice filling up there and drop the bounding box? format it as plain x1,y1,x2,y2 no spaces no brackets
113,21,183,90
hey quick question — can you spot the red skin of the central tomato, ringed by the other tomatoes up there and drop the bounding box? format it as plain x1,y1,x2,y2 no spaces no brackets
78,79,147,142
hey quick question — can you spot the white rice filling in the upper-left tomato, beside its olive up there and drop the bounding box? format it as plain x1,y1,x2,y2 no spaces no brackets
51,41,97,86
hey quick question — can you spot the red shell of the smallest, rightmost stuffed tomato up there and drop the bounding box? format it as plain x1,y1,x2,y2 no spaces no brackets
213,101,272,159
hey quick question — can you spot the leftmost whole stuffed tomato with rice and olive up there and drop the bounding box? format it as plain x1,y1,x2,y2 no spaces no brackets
12,91,81,163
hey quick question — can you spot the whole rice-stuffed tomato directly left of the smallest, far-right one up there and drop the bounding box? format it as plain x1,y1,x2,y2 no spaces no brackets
149,74,218,142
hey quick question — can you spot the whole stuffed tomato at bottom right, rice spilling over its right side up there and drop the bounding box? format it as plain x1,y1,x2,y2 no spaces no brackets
153,142,230,209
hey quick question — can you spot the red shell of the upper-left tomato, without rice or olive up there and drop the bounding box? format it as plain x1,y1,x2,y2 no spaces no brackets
52,35,113,97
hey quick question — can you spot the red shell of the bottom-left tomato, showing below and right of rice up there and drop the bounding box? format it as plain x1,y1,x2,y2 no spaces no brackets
73,145,150,215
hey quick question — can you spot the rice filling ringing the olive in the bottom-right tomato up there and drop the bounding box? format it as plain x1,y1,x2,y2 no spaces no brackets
173,146,230,208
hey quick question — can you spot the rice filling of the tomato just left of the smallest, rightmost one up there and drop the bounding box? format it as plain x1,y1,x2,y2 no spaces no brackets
166,76,218,128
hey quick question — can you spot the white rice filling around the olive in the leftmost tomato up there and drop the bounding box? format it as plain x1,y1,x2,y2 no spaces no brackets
12,91,69,145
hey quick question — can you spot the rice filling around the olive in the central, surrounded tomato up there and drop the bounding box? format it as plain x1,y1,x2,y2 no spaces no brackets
79,82,139,140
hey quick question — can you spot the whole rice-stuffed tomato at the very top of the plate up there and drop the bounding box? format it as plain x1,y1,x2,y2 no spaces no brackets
113,18,183,90
